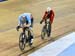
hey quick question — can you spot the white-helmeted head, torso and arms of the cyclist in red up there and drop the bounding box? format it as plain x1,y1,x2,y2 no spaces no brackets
40,7,55,24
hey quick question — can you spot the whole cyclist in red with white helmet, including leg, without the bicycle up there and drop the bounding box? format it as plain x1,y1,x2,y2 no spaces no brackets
40,7,55,37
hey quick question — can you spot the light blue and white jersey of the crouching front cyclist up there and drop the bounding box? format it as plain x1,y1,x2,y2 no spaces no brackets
18,13,31,25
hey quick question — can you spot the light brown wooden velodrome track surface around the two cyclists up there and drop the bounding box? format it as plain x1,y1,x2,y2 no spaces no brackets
0,0,75,56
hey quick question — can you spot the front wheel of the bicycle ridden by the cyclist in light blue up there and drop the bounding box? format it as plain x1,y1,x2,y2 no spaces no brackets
19,33,26,51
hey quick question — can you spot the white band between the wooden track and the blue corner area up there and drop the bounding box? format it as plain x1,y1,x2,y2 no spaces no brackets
28,32,75,56
